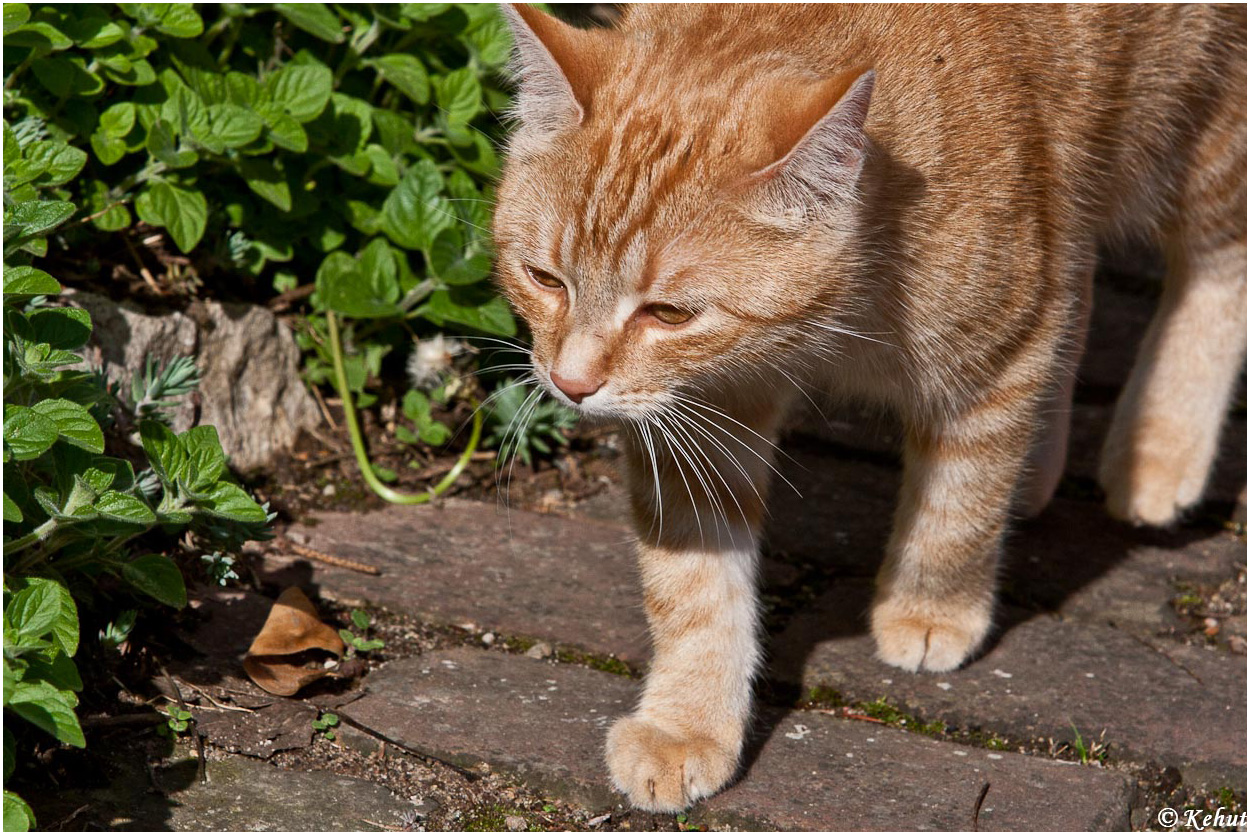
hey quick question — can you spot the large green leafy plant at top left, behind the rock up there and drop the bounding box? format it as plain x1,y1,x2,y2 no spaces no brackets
5,4,527,499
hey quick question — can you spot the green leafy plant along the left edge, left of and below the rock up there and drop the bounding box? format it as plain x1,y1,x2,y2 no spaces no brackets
3,122,271,829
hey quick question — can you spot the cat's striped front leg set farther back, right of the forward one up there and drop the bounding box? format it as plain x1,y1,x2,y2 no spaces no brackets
871,383,1038,673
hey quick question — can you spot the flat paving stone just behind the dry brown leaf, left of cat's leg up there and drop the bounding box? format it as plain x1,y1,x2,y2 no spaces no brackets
263,500,646,660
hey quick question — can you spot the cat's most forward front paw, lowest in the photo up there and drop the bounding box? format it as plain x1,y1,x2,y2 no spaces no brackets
608,716,738,813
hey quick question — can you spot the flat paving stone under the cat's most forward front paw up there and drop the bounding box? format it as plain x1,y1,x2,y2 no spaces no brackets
341,648,1133,831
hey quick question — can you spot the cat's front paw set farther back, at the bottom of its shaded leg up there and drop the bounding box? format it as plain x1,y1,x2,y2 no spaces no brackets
873,598,990,673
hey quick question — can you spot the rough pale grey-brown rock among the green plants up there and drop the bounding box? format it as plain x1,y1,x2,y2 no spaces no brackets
66,291,321,471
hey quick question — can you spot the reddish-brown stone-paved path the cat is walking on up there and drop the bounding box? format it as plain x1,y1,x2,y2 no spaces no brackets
148,275,1246,830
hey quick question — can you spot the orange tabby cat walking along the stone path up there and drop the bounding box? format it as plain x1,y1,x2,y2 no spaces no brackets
495,5,1246,810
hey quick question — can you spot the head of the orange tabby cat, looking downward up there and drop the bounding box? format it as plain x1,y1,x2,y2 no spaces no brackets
495,6,874,418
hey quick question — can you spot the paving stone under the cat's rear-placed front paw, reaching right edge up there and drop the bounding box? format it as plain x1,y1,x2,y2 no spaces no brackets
771,581,1246,785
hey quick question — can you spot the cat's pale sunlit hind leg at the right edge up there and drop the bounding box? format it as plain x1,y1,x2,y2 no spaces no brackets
1099,238,1246,525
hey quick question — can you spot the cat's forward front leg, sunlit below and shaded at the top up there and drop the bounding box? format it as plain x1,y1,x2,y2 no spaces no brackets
606,400,770,811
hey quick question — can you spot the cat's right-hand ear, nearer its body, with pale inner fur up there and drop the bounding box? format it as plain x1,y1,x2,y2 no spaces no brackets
754,69,876,221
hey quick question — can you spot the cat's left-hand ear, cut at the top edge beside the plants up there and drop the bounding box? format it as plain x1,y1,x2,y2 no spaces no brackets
504,4,618,147
